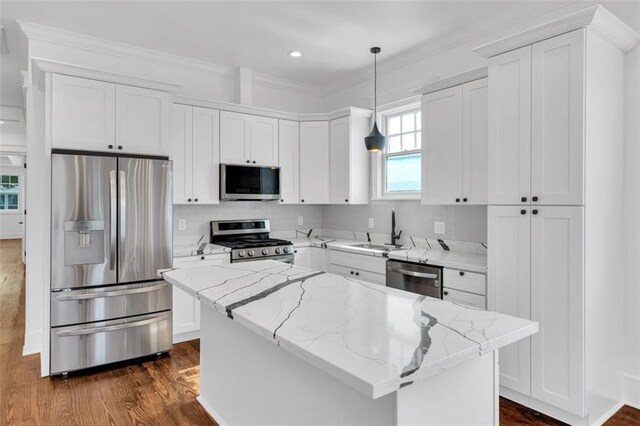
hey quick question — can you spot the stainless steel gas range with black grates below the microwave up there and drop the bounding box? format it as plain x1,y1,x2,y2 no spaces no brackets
210,219,293,263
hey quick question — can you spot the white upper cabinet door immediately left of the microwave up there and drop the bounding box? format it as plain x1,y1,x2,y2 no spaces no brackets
190,107,220,204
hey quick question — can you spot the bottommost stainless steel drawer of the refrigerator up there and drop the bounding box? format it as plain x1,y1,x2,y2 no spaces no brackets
51,311,172,374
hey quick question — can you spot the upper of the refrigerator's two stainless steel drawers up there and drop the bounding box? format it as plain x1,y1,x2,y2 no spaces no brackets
51,281,172,327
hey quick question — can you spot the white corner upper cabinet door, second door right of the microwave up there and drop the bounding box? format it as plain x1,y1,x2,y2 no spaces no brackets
300,121,329,204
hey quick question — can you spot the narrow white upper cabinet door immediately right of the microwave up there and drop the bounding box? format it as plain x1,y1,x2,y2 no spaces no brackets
278,120,300,204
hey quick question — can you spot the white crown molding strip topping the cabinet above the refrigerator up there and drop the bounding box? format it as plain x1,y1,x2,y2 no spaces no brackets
31,58,182,93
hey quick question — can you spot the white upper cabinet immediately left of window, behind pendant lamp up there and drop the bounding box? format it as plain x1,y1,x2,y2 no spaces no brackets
329,114,370,204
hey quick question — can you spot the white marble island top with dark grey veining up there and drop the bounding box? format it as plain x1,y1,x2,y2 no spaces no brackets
163,260,538,398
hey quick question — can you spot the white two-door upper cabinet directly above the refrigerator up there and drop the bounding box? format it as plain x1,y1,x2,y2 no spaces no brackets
51,74,171,155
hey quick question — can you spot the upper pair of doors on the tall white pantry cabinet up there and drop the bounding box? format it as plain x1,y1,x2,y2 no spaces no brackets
488,30,585,205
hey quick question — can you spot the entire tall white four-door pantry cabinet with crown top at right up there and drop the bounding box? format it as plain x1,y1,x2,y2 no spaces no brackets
476,6,638,424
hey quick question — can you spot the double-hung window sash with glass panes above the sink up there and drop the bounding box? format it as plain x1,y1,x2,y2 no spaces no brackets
382,108,422,195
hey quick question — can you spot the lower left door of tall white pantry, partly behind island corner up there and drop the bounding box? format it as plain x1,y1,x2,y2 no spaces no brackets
487,206,531,395
